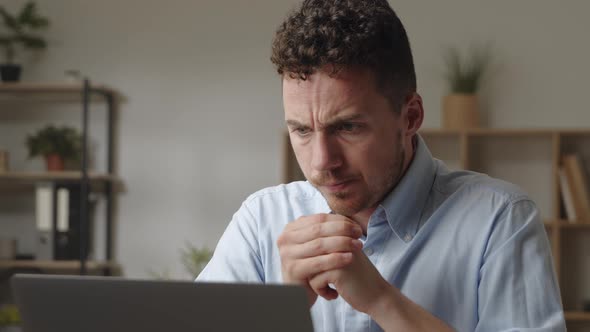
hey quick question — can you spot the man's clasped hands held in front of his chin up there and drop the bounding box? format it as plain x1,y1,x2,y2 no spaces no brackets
277,214,390,313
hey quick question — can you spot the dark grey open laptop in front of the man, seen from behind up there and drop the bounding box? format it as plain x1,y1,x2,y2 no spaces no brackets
11,274,313,332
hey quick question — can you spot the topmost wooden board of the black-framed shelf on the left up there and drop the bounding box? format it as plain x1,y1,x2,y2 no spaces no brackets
0,82,116,95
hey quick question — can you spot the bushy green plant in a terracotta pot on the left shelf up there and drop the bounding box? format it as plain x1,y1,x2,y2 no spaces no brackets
26,125,82,171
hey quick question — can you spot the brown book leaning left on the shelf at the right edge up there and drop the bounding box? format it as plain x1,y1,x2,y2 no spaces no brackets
562,154,590,223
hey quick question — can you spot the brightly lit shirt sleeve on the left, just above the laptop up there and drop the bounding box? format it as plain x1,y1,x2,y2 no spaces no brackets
196,203,264,283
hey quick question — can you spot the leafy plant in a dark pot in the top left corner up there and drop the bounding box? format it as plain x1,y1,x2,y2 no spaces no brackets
0,1,49,82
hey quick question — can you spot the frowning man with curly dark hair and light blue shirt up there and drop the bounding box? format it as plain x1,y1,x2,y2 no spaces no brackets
198,0,565,331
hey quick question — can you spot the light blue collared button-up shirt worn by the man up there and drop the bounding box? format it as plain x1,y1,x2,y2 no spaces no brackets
197,137,565,332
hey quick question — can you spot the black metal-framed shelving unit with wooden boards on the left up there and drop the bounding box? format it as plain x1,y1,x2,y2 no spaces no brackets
0,80,122,275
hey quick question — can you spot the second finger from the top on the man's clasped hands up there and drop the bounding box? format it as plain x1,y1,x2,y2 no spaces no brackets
277,220,363,246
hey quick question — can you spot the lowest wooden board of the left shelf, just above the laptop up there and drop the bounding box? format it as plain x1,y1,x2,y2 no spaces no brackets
0,260,120,271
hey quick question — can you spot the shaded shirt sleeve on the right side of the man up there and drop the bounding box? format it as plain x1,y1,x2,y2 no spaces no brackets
476,199,566,332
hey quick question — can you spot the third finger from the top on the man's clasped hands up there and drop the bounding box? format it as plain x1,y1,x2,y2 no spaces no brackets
281,236,363,259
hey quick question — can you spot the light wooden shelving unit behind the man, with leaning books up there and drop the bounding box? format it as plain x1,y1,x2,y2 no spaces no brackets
283,128,590,331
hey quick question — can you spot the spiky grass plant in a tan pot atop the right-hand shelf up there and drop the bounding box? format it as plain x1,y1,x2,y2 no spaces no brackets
443,46,490,129
